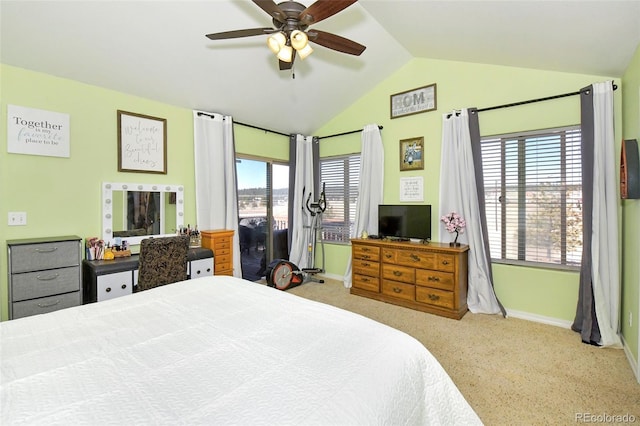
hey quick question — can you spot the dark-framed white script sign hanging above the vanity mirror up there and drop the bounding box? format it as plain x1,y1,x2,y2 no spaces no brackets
118,110,167,174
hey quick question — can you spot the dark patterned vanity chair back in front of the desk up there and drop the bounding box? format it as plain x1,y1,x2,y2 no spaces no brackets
134,235,189,292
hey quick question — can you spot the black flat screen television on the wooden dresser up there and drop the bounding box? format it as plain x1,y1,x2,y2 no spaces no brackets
378,204,431,240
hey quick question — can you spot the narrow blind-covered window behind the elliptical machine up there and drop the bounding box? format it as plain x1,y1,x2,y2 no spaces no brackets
320,154,360,243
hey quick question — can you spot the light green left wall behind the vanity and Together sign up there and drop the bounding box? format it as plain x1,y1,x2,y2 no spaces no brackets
0,64,288,320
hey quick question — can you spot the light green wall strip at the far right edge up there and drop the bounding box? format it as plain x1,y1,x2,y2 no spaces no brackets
621,45,640,362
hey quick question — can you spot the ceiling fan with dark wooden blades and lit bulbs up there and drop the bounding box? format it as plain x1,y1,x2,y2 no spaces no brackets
207,0,366,70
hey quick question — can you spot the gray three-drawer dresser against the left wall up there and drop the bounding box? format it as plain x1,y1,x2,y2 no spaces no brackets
7,235,82,319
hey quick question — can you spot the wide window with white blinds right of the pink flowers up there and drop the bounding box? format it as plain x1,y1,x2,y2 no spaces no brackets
481,126,582,268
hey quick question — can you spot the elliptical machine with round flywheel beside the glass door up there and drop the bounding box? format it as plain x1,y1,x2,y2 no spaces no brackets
266,183,327,290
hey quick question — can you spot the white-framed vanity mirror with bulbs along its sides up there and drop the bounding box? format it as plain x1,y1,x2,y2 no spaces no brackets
102,182,184,245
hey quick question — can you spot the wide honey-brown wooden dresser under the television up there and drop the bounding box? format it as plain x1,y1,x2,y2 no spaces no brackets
351,239,469,319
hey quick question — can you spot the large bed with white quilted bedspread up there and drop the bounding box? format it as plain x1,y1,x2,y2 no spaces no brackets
0,276,481,425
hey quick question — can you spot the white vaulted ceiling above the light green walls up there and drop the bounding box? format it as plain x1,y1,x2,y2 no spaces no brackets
0,0,640,134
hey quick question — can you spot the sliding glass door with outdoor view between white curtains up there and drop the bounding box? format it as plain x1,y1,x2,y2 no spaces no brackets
236,156,289,281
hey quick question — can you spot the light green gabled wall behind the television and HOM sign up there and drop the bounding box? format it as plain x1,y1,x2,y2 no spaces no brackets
316,55,624,321
